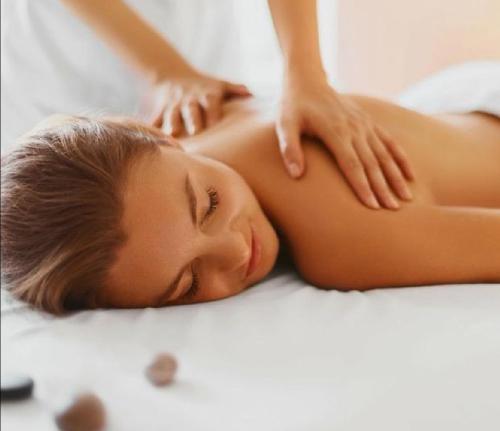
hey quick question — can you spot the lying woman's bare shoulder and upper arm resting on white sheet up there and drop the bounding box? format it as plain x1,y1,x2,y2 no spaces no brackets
272,143,500,290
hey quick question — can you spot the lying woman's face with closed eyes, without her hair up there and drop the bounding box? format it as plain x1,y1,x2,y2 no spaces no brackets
103,137,278,307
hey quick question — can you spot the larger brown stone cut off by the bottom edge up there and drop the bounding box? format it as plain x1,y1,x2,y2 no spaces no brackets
56,393,106,431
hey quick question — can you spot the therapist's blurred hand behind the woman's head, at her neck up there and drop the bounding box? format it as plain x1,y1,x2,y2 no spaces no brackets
147,72,250,136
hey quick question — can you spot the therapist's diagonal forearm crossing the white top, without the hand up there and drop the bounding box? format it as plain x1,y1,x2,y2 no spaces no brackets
61,0,195,83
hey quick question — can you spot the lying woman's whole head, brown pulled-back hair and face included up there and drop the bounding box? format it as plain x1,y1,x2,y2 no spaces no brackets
1,117,277,313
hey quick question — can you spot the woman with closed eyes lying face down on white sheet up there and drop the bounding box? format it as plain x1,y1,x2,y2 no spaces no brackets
1,96,500,313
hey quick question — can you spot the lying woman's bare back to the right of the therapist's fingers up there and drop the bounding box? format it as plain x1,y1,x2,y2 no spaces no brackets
355,97,500,208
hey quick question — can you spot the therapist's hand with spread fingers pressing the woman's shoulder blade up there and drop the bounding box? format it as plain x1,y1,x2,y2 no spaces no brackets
276,73,414,209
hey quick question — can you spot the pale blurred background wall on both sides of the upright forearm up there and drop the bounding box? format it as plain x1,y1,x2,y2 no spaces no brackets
230,0,500,97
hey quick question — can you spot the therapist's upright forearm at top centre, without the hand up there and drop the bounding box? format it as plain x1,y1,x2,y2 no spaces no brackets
268,0,325,75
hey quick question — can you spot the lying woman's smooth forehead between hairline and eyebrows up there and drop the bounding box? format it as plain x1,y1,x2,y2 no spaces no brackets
107,148,192,294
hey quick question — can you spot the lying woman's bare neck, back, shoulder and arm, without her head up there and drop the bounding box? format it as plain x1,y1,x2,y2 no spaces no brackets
181,96,500,289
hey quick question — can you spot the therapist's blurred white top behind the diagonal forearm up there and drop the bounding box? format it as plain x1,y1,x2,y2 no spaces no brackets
1,0,241,154
